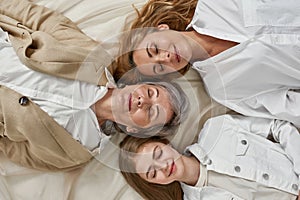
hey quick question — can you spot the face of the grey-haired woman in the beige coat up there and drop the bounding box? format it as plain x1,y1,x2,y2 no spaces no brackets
112,84,174,132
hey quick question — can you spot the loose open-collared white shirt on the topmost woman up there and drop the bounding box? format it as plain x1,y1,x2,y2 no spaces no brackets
188,0,300,127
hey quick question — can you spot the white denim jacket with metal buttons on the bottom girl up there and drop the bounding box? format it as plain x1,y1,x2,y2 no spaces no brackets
182,115,300,200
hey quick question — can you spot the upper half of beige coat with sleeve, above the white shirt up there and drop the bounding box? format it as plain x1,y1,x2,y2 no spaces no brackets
0,0,113,85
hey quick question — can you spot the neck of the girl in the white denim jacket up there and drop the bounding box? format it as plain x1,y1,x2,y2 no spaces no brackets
179,156,200,186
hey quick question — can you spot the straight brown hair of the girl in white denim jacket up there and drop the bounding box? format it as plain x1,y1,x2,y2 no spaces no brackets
119,136,183,200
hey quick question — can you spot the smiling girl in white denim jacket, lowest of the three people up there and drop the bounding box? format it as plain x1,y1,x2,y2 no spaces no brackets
119,115,300,200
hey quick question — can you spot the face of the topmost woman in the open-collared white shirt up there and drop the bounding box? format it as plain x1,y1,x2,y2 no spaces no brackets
133,25,192,76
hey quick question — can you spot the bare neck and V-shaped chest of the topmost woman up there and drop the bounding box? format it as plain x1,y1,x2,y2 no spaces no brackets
184,30,238,61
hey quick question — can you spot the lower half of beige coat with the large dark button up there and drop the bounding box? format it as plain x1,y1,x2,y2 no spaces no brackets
0,86,92,171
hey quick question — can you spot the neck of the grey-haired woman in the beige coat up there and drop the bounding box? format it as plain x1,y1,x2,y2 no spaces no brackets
93,89,115,125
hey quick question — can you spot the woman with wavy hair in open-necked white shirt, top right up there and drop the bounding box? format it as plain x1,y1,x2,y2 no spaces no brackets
117,0,300,127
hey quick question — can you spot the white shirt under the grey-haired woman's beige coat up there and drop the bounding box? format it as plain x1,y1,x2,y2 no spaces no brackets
0,29,111,151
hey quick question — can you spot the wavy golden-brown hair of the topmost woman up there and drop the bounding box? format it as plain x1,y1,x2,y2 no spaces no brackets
114,0,198,83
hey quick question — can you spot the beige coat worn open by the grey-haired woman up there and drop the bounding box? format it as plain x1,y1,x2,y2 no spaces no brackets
0,0,110,170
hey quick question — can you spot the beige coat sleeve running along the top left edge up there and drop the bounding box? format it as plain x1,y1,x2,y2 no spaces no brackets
0,0,98,48
